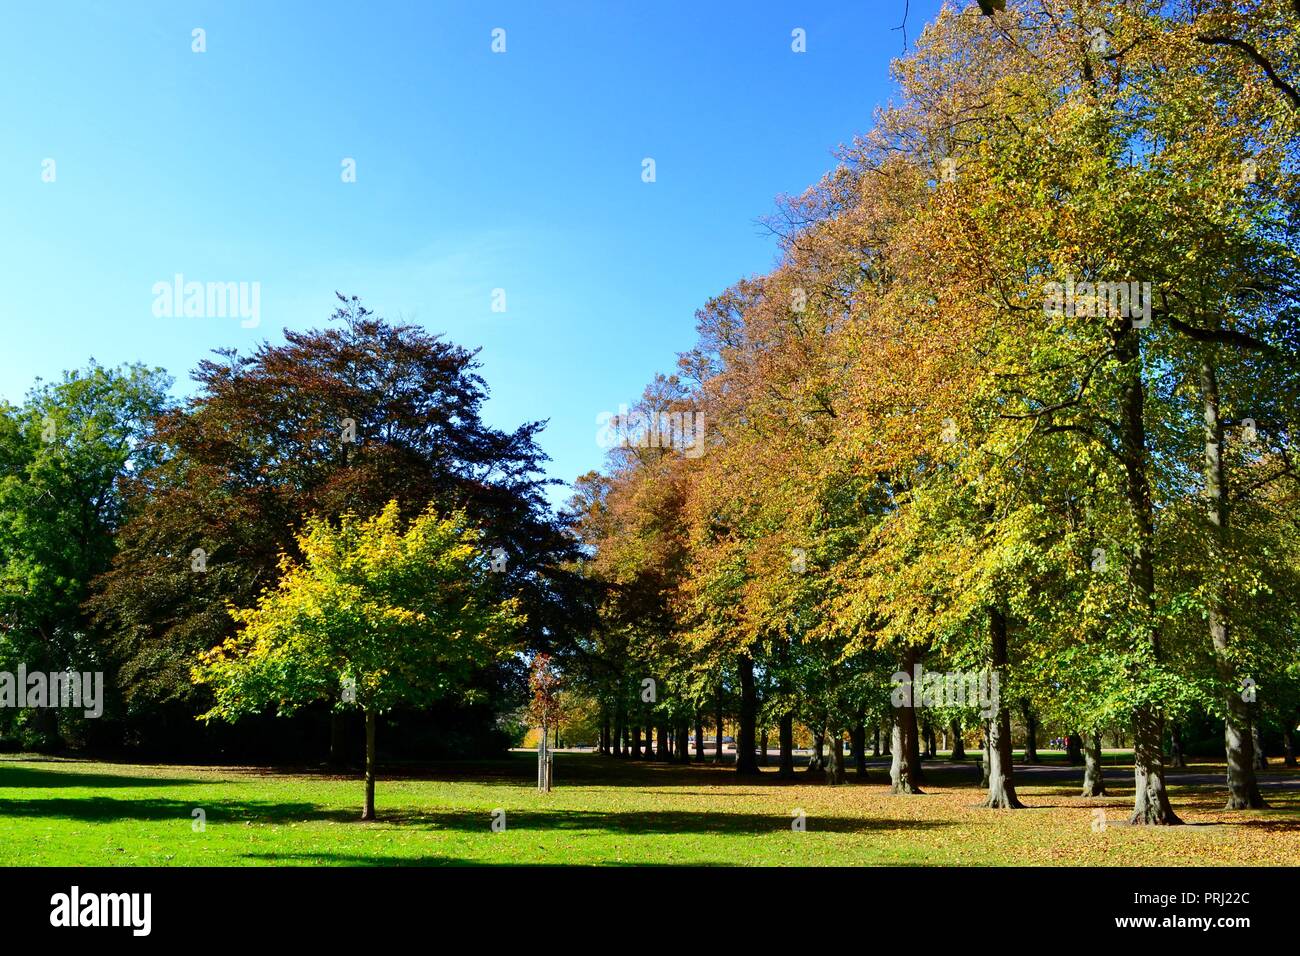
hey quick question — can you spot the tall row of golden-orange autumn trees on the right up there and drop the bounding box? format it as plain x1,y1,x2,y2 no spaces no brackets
569,0,1300,823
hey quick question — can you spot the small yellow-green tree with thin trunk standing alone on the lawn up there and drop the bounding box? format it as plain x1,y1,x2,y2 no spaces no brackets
192,501,523,819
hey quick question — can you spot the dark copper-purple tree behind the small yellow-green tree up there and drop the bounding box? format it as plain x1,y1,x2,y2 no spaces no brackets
90,295,579,757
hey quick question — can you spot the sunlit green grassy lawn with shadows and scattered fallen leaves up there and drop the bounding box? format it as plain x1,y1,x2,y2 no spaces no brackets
0,753,1300,866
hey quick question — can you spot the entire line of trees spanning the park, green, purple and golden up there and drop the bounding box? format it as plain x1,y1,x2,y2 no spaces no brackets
0,0,1300,823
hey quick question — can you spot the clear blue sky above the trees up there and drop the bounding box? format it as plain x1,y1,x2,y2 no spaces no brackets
0,0,939,509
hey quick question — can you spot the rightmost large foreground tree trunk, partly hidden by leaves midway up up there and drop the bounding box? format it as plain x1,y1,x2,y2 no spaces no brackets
1201,359,1266,810
